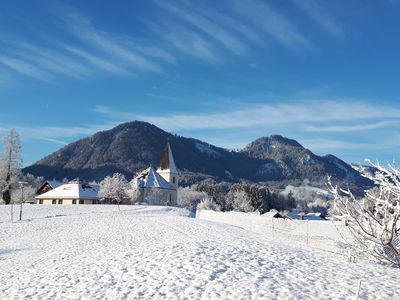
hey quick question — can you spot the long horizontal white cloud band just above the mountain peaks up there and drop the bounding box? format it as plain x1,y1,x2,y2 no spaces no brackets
94,100,400,131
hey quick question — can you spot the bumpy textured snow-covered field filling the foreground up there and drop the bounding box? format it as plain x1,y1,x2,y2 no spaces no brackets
0,205,400,299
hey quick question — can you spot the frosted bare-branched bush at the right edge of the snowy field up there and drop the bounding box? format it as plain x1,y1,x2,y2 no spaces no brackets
328,164,400,267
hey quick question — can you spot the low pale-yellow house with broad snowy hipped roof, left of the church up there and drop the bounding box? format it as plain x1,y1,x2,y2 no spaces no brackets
35,181,99,205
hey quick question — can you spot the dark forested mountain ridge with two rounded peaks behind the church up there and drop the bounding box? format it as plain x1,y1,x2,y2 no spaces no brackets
24,121,366,189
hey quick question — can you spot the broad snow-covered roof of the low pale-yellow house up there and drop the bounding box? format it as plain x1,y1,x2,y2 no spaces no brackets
35,182,99,200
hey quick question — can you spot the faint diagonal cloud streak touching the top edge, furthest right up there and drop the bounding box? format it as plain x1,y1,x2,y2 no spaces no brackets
293,0,344,38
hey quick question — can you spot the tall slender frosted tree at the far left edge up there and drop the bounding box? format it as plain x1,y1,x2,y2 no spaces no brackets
0,130,22,204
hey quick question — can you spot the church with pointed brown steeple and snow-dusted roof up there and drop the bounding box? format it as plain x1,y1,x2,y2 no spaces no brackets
131,142,178,205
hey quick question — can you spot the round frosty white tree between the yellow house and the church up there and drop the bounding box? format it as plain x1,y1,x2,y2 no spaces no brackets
99,173,127,206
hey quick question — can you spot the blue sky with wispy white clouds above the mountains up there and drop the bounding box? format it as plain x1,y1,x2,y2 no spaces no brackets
0,0,400,165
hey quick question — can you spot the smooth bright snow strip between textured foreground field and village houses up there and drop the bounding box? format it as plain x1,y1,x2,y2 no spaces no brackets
196,210,350,252
